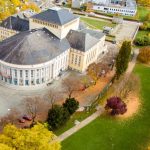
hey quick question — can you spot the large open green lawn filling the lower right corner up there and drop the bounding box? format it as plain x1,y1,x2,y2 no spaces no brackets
62,64,150,150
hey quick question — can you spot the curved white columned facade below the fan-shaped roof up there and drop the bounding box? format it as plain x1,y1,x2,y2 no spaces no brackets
0,50,69,87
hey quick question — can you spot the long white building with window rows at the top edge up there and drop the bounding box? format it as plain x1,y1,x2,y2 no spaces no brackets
72,0,137,16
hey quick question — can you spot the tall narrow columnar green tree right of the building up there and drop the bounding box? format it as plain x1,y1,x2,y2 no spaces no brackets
116,41,131,79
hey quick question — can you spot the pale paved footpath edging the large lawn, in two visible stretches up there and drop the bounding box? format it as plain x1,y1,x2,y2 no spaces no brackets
55,49,139,142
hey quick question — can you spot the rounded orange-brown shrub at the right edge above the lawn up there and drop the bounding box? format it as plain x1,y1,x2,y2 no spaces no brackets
138,46,150,63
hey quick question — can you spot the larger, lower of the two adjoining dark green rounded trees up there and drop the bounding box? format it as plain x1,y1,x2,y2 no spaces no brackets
47,105,70,130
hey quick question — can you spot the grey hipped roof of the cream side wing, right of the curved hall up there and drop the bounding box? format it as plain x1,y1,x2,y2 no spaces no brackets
67,29,104,52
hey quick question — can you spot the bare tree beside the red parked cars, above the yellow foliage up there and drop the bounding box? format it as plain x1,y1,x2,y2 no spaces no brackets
24,97,49,126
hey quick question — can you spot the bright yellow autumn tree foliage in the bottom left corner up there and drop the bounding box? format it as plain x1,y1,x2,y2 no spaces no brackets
0,124,61,150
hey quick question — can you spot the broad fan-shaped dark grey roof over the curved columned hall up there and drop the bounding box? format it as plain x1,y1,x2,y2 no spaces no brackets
0,28,70,65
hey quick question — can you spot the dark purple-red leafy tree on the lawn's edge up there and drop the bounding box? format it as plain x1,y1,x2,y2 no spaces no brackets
105,97,127,115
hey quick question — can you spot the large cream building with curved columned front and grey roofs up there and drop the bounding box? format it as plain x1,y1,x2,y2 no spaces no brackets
0,8,107,89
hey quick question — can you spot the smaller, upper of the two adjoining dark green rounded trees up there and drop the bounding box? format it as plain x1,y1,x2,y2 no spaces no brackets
63,98,79,115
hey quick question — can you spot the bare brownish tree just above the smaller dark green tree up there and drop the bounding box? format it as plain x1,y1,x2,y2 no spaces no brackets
62,76,81,98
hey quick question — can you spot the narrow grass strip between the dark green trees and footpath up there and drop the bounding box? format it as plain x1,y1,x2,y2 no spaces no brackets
54,110,95,135
